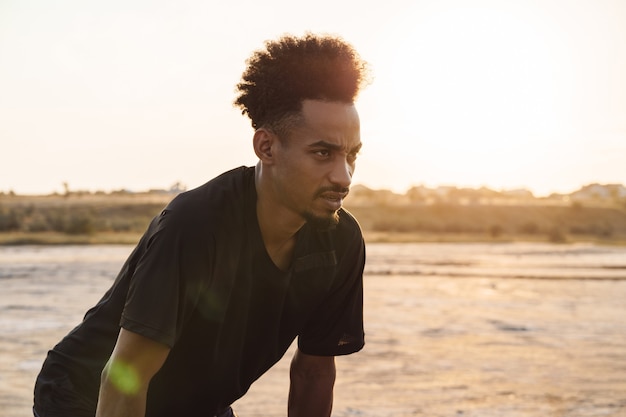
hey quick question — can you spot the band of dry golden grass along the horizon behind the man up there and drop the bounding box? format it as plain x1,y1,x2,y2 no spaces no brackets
0,193,626,245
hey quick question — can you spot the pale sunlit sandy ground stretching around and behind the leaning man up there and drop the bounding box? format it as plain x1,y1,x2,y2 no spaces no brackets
0,244,626,417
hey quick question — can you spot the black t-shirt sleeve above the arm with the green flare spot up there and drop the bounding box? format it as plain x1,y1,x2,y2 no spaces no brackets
120,209,210,347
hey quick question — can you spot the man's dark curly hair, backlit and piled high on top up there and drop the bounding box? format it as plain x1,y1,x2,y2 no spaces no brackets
234,33,368,129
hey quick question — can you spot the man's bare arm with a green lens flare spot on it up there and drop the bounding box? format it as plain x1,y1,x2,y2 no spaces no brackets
96,329,170,417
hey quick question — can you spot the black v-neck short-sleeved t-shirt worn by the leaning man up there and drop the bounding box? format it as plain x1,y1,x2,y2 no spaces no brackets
36,167,365,417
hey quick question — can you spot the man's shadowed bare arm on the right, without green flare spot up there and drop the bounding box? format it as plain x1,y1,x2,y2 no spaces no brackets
288,349,336,417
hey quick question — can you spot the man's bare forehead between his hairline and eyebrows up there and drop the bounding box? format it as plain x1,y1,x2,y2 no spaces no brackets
297,100,361,147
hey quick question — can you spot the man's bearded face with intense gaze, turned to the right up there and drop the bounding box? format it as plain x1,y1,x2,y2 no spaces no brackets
273,100,361,227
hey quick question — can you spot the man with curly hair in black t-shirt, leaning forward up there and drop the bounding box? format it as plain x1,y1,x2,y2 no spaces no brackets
34,34,365,417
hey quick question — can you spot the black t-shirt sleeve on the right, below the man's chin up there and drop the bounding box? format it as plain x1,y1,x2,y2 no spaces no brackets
298,231,365,356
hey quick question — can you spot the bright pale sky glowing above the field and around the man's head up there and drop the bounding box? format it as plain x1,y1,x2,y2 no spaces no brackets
0,0,626,195
